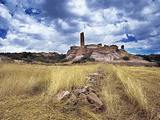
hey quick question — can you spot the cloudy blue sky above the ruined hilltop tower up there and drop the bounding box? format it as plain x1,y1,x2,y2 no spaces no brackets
0,0,160,54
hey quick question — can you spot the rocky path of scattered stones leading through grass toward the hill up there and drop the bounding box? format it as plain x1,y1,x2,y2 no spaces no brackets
56,69,105,112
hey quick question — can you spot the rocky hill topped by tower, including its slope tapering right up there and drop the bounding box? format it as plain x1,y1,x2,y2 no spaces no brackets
66,32,148,62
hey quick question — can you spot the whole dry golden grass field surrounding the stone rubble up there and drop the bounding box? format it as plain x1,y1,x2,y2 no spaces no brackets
0,64,160,120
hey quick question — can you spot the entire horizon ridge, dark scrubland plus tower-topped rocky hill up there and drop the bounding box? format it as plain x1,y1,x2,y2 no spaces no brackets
0,32,160,66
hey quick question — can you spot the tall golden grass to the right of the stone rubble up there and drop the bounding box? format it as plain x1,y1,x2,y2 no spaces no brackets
101,65,160,120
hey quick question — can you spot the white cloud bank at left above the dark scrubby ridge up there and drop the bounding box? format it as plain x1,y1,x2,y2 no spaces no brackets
0,2,69,52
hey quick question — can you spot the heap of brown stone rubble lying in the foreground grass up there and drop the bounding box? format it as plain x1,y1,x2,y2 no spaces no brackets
56,73,104,111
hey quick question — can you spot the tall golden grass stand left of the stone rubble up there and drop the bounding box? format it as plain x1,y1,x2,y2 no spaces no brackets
0,64,97,96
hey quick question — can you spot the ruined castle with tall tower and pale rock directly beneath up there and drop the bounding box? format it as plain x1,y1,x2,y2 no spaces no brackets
67,32,128,61
